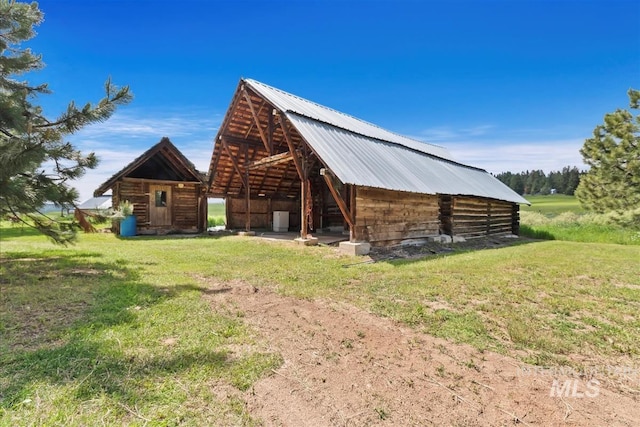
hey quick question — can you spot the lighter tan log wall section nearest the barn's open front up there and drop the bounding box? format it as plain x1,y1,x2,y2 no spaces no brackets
354,187,440,246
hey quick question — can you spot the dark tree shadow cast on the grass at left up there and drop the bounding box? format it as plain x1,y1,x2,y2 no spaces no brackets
0,253,236,413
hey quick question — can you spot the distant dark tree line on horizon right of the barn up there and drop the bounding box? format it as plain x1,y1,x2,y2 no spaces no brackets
496,166,585,196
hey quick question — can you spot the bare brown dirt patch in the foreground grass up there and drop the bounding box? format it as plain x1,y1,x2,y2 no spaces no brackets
205,281,640,426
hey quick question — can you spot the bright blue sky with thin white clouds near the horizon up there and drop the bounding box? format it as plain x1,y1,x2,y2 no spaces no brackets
25,0,640,199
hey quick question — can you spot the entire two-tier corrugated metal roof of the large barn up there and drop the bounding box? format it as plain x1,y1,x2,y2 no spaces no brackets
244,79,530,204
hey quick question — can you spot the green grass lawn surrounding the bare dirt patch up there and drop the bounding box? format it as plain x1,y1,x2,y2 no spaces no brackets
0,224,640,426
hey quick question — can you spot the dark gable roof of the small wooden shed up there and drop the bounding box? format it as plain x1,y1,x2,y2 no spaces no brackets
93,136,204,197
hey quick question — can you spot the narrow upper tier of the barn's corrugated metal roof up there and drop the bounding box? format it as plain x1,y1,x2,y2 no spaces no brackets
244,79,453,160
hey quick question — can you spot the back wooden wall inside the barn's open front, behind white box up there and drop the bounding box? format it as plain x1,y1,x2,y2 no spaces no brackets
226,197,300,231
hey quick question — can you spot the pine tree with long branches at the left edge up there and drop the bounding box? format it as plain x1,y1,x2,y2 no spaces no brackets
0,0,132,244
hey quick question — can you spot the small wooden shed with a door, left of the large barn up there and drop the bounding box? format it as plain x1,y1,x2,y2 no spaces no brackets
94,137,207,234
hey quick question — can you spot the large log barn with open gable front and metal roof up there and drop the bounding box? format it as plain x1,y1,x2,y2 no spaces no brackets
208,79,528,246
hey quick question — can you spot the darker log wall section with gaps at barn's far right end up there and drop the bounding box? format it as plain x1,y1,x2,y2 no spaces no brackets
450,197,519,239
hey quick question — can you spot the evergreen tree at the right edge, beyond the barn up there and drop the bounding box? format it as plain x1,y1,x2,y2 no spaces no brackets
575,89,640,212
